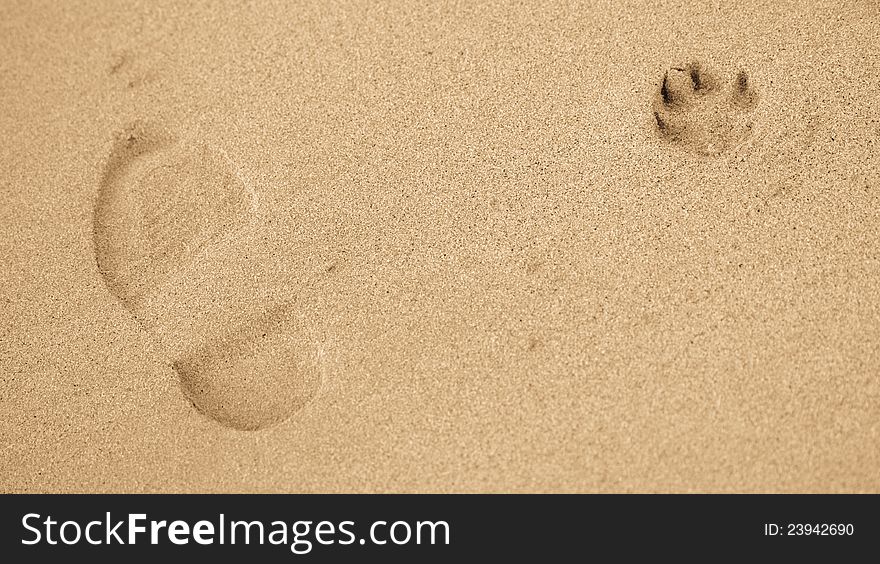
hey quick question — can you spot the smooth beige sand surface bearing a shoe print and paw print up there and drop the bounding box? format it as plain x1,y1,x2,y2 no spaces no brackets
0,0,880,492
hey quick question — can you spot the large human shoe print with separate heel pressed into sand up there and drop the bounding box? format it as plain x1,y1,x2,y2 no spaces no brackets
94,122,320,430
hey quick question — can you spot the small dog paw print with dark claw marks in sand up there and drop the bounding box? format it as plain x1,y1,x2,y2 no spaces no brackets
653,63,758,157
